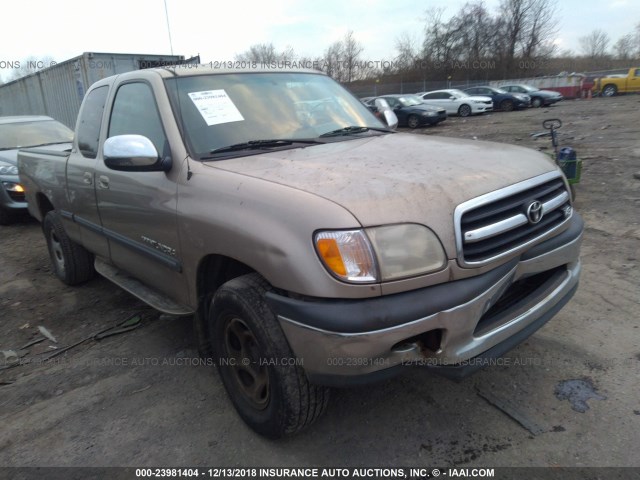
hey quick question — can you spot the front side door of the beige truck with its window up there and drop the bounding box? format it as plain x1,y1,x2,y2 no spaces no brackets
96,81,187,298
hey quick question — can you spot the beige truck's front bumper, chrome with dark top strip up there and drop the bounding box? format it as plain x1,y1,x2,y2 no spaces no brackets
267,212,584,386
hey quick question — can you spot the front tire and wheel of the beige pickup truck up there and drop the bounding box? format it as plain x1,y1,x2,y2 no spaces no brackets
208,273,329,438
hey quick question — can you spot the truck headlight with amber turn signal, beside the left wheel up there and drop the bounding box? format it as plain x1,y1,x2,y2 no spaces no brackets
315,224,446,283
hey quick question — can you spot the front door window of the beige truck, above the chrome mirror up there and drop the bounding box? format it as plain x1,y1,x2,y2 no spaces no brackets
107,83,169,157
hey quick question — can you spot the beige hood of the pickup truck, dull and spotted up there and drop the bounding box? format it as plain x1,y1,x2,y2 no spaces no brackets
206,133,556,255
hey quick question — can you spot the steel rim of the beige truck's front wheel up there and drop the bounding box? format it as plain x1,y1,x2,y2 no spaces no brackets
224,317,270,410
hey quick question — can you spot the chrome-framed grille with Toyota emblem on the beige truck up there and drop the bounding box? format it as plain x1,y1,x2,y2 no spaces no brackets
456,174,571,265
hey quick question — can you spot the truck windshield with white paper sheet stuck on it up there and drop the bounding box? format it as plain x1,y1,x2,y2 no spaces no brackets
166,72,386,158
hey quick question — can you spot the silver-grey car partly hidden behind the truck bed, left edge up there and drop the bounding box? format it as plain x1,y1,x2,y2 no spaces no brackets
0,115,73,225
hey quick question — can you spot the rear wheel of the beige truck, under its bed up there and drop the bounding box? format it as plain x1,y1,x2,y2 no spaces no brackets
42,211,95,285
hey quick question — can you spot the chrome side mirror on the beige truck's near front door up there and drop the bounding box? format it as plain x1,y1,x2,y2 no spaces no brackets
102,135,171,172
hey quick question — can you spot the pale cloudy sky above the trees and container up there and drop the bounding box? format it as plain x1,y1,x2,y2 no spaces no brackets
0,0,640,80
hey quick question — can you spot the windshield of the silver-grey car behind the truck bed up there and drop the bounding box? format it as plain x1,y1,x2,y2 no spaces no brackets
0,120,73,150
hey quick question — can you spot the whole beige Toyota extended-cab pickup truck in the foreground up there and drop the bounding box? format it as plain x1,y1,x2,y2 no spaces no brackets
19,66,583,437
